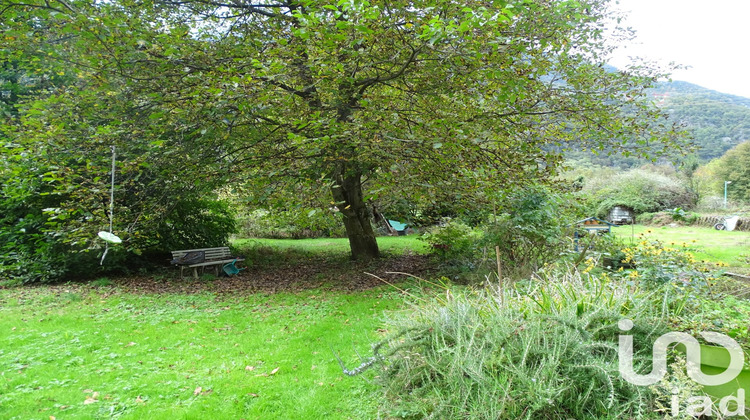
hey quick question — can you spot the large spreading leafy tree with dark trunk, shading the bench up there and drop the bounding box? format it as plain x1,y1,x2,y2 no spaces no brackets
0,0,688,259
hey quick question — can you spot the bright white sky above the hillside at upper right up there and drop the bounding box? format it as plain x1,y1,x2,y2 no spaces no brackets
611,0,750,98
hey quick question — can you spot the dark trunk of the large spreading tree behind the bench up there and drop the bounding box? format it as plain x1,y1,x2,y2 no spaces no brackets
331,168,380,260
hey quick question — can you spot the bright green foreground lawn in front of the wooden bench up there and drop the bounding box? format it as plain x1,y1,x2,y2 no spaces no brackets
0,286,414,419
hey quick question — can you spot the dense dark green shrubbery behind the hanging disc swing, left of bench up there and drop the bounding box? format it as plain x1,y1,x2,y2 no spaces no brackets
0,77,241,282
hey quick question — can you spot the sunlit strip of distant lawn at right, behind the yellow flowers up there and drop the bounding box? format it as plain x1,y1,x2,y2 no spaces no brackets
613,225,750,273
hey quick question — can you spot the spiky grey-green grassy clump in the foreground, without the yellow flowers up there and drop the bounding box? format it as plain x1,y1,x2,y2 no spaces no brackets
346,273,680,419
